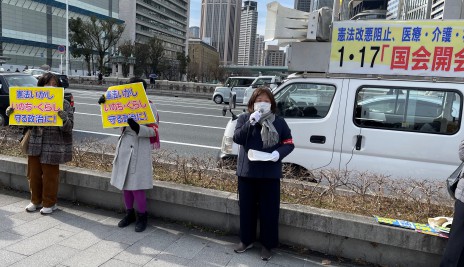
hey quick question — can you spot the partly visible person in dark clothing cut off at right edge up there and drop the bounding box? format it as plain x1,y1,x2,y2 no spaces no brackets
440,140,464,267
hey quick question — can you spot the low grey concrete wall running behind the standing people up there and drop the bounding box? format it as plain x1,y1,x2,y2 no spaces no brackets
0,155,446,266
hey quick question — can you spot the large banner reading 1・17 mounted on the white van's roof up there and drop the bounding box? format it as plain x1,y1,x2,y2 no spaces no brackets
329,20,464,77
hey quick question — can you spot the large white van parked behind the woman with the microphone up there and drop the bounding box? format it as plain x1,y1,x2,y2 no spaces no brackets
220,74,464,179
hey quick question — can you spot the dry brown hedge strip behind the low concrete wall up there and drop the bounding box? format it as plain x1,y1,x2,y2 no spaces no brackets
0,128,453,223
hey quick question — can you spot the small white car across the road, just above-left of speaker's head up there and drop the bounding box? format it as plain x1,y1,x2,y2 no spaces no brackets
213,77,256,104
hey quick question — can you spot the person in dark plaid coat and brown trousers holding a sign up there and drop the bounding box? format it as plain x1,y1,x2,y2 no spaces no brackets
6,72,74,214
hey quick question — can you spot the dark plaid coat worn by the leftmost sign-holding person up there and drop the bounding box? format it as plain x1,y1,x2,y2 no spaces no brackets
27,100,74,164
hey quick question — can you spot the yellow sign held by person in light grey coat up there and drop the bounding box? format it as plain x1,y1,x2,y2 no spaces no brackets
101,83,155,128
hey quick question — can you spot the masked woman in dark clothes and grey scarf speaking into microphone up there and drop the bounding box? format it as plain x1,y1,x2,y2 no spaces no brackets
234,87,295,261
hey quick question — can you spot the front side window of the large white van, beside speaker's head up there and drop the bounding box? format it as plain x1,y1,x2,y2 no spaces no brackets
275,83,335,119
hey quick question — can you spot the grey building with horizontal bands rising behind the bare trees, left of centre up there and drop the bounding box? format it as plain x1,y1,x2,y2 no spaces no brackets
119,0,189,59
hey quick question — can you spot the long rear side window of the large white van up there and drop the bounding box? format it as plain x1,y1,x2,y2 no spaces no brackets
354,87,462,134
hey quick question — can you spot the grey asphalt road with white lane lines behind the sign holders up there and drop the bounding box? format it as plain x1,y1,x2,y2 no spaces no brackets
66,89,236,158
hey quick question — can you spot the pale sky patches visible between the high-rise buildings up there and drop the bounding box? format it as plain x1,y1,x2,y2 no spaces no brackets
189,0,295,35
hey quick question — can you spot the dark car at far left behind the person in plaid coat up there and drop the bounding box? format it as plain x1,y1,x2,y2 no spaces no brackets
0,72,75,126
